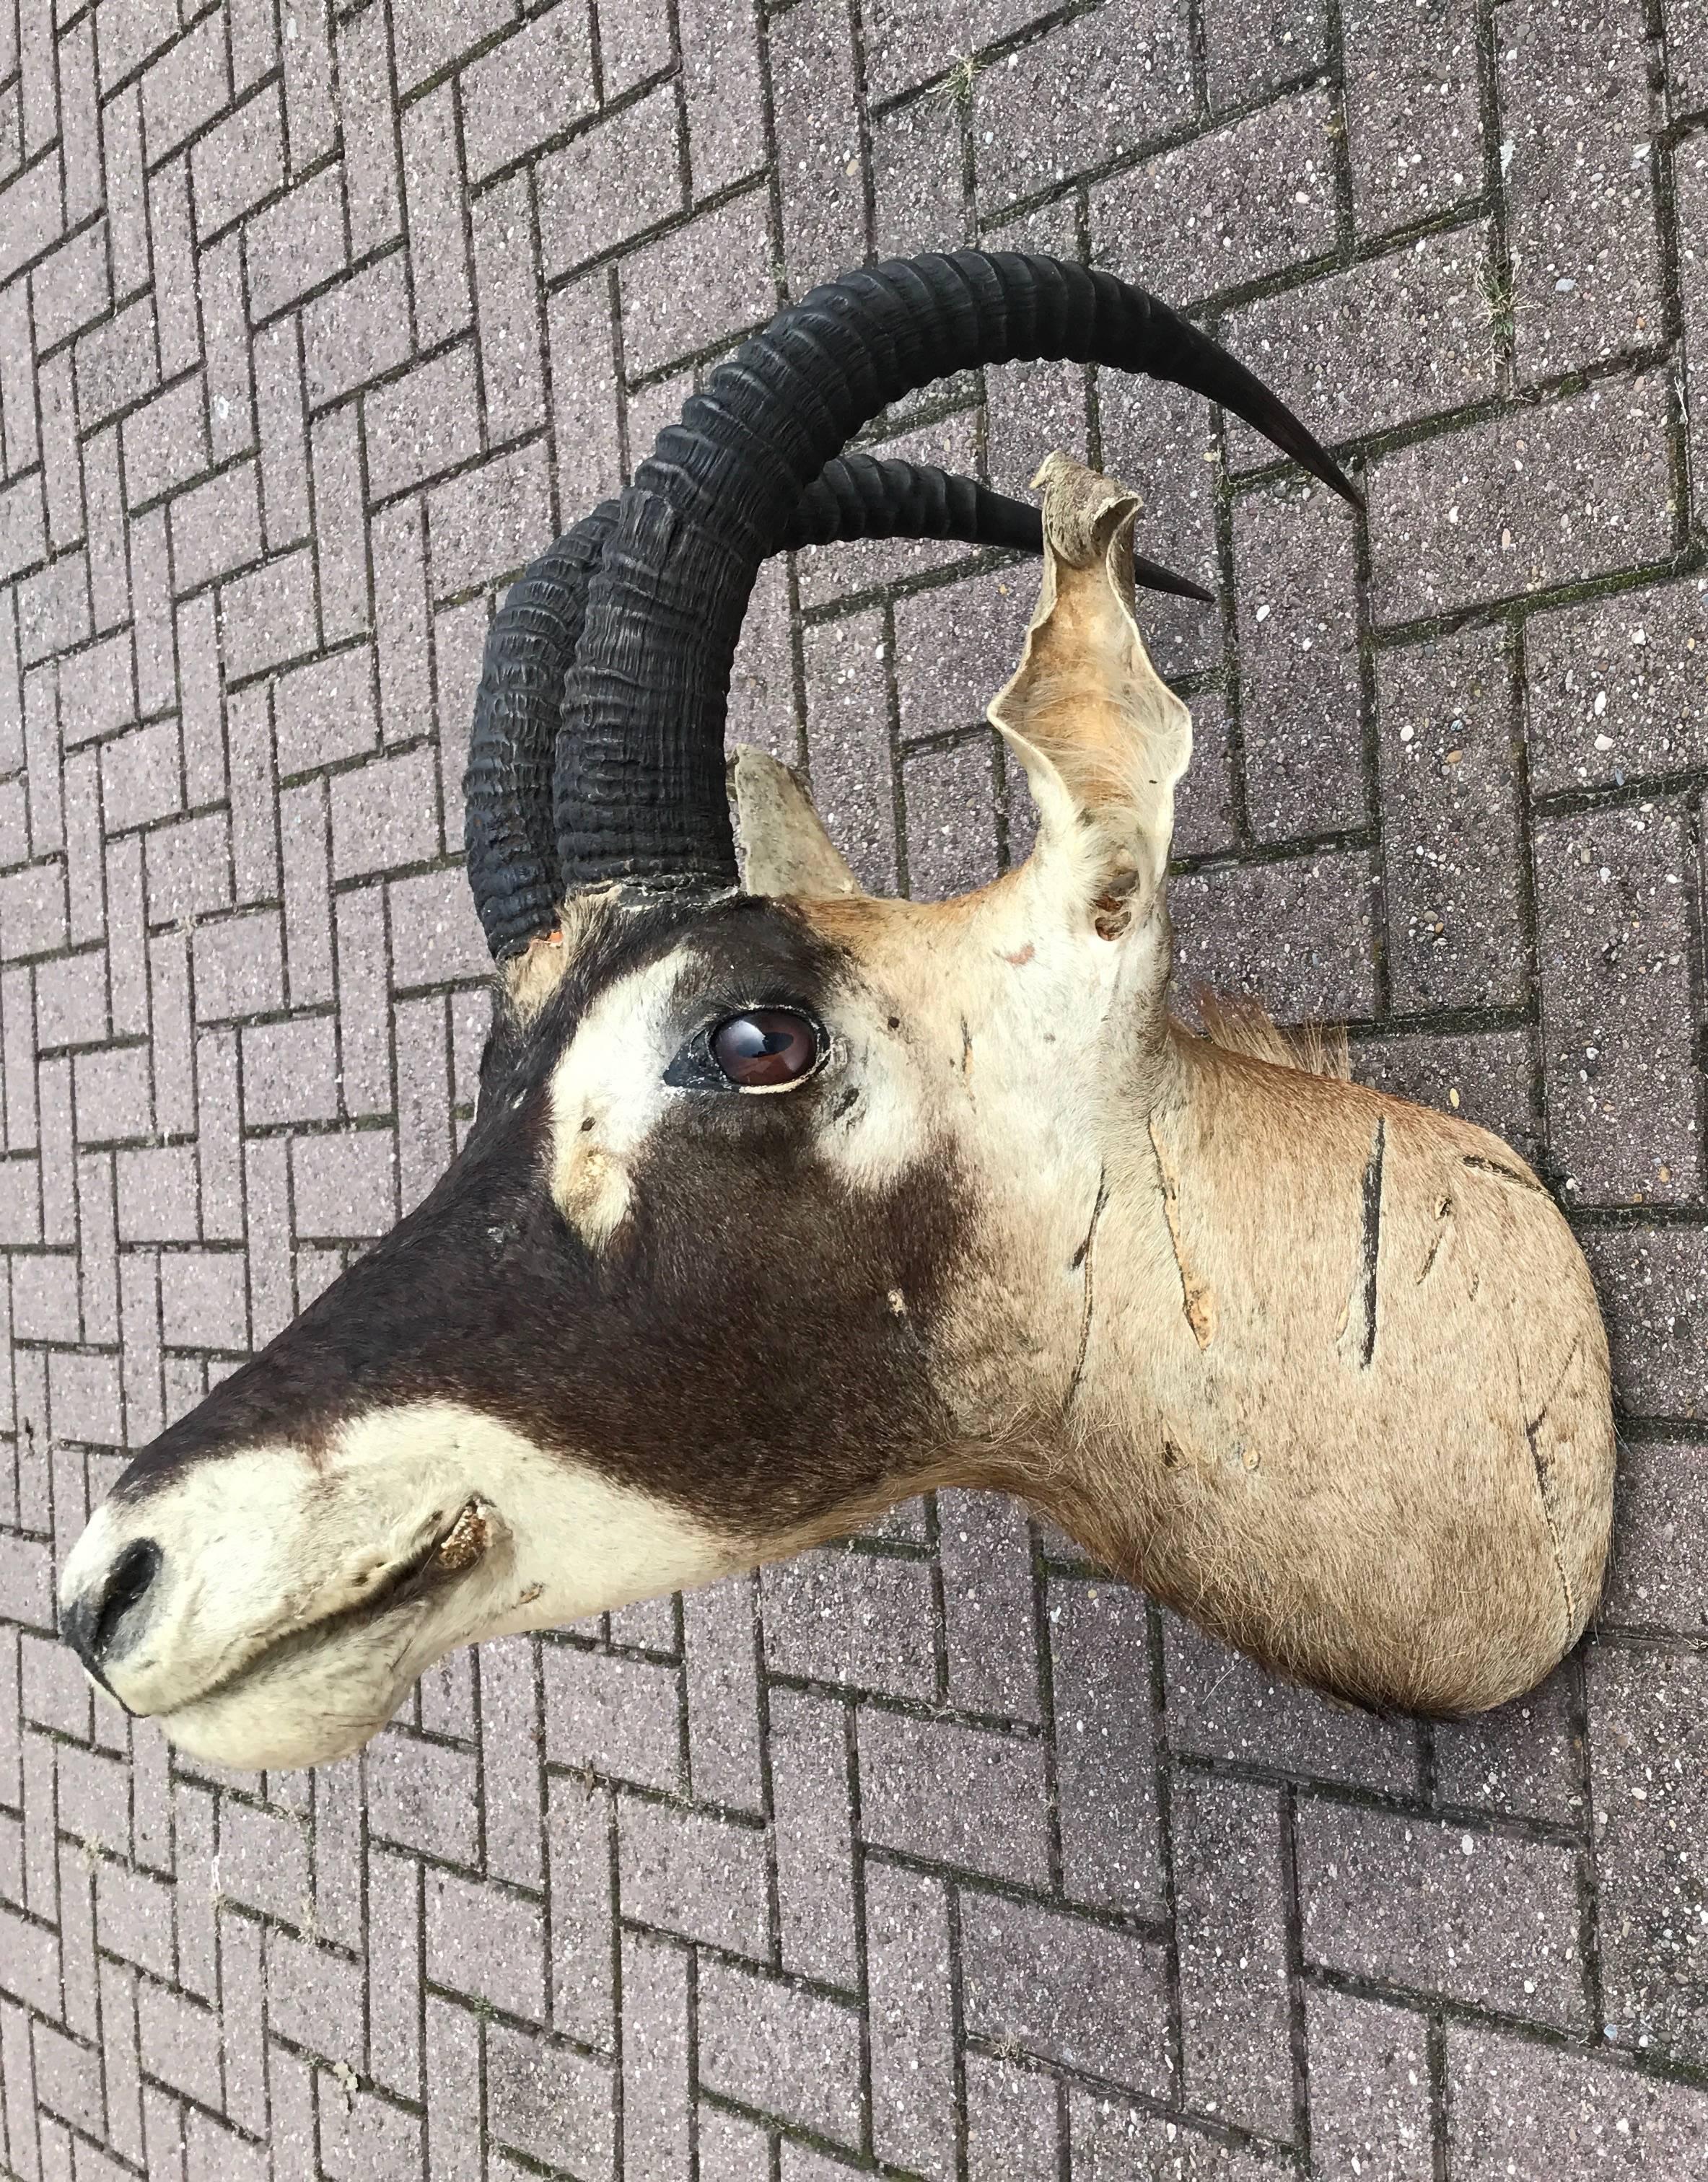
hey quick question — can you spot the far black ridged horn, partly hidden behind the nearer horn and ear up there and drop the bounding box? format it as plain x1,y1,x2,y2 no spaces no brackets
463,454,1211,958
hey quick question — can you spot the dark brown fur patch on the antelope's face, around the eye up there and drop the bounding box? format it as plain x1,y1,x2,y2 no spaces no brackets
118,899,968,1536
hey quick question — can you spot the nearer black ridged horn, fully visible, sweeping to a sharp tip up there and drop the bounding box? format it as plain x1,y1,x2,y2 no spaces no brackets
552,251,1357,890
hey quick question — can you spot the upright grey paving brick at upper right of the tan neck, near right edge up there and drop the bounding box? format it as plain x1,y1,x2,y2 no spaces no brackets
1536,805,1702,1204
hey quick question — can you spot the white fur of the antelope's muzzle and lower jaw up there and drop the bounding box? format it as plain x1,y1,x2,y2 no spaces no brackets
66,1401,737,1767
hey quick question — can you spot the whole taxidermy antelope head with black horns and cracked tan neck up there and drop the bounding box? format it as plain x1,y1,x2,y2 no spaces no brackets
63,251,1612,1765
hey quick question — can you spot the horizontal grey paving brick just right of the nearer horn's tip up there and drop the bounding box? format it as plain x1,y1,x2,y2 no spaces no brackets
1370,373,1673,622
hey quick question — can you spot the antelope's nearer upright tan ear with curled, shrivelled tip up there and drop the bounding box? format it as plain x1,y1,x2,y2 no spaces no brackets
988,454,1191,938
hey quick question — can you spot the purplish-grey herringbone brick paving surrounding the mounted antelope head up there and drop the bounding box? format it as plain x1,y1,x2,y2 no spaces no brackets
0,0,1708,2182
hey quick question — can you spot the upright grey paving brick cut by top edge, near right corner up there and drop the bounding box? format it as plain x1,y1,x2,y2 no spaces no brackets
1499,0,1663,380
